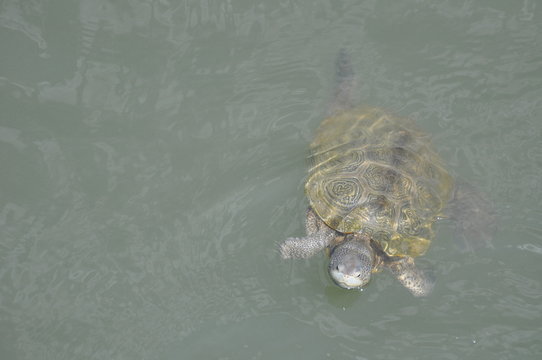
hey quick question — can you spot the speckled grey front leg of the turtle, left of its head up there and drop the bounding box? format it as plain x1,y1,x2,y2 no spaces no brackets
280,208,339,259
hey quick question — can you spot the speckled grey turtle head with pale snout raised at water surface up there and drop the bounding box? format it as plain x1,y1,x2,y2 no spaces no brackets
328,238,375,289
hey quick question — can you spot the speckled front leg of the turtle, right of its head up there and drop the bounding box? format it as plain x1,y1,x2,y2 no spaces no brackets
385,256,435,297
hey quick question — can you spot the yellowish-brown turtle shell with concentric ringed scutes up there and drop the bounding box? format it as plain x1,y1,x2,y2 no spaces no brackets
305,108,453,257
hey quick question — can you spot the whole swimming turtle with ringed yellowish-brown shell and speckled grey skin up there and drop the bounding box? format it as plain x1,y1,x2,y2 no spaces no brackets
280,50,493,297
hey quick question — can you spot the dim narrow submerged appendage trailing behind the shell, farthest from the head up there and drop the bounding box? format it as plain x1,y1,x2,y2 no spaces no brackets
329,49,355,115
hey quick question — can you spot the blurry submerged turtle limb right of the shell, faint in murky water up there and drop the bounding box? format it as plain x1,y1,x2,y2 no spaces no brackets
447,182,496,252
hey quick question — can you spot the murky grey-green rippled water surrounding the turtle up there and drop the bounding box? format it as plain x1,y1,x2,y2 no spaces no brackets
0,0,542,360
